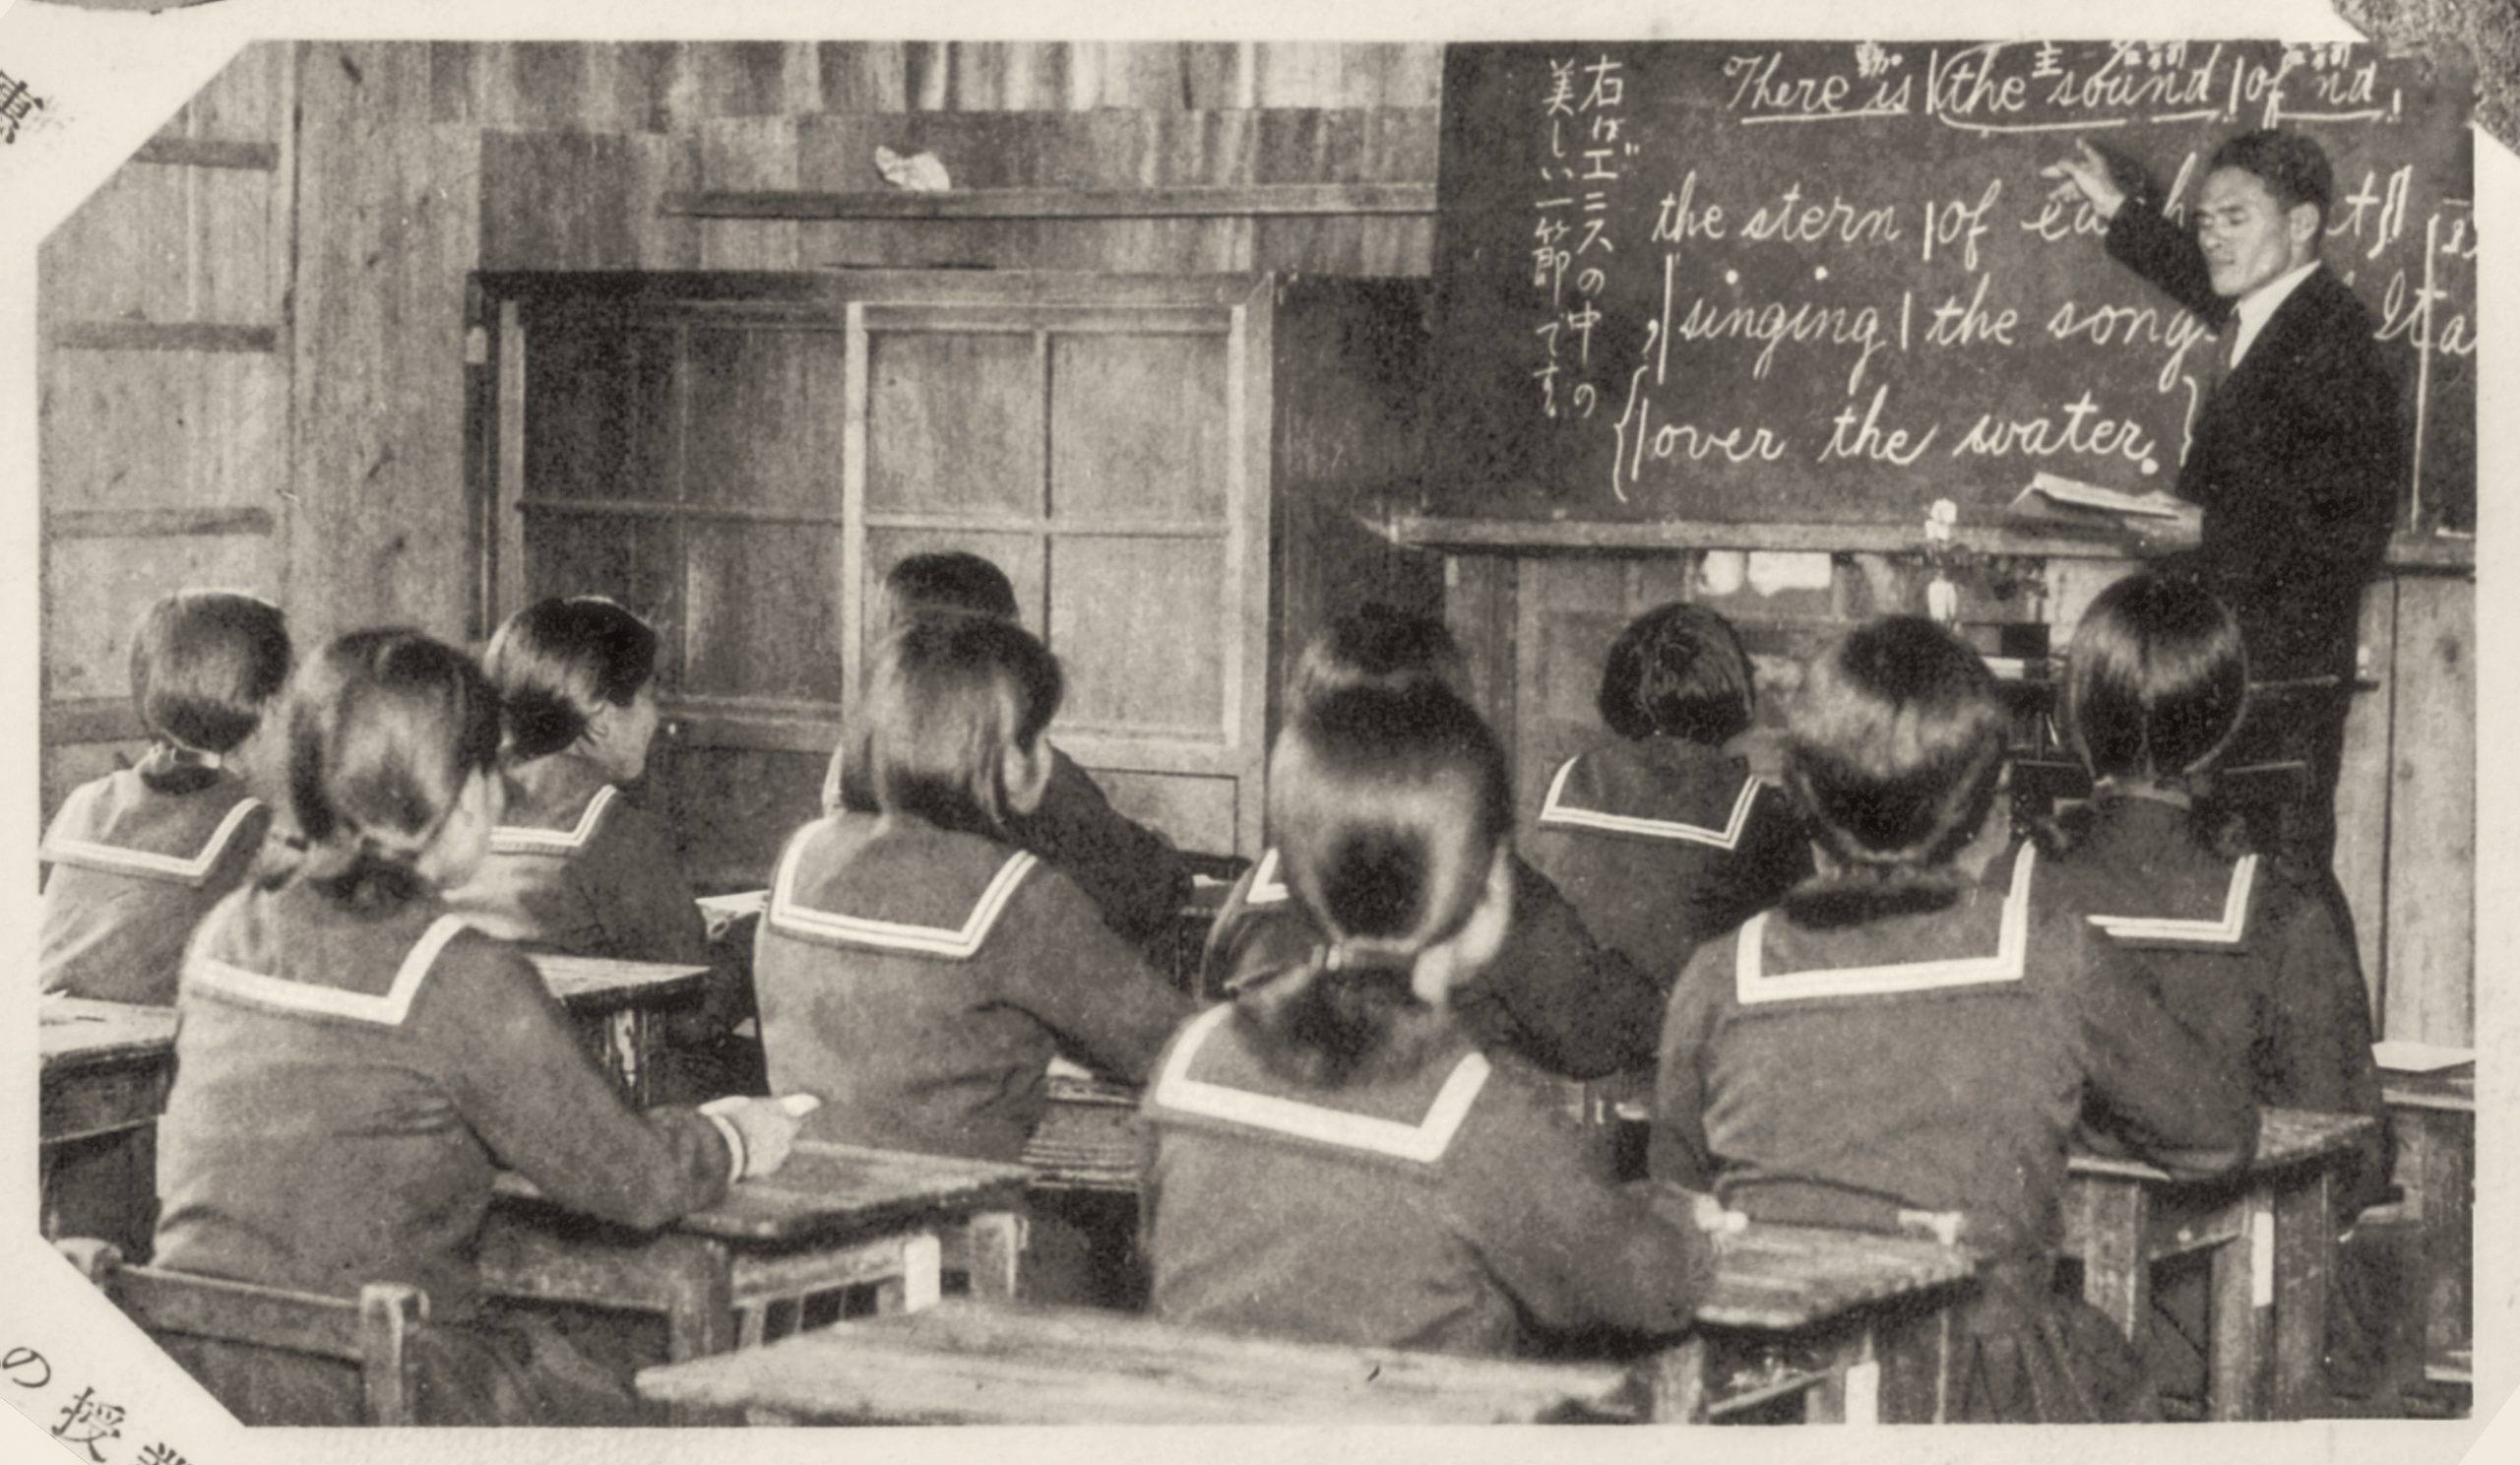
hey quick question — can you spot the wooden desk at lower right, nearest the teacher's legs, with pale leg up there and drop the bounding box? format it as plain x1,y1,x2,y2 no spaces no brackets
2064,1110,2371,1420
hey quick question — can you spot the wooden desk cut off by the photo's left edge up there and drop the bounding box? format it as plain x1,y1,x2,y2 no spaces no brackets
37,996,176,1261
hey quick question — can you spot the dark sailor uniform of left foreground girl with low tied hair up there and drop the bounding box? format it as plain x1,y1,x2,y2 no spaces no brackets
157,882,733,1425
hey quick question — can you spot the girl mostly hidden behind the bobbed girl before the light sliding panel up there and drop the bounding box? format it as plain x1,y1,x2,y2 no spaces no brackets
822,549,1189,945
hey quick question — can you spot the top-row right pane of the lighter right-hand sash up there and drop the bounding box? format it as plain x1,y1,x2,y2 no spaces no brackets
1051,336,1228,520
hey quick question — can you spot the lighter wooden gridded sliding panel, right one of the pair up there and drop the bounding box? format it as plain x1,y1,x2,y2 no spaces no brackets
845,285,1268,855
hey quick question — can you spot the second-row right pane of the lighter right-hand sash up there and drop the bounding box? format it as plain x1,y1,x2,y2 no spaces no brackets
1051,535,1232,741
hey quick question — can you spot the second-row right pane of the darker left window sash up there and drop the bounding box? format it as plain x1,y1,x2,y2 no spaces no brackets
683,522,842,704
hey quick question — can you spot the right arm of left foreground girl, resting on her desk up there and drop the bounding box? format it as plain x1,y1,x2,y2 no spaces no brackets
410,933,730,1228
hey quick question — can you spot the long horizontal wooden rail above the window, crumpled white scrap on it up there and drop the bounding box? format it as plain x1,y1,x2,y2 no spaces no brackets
658,184,1434,220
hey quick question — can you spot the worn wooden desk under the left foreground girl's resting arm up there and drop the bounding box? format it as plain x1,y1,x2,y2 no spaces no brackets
481,1140,1031,1359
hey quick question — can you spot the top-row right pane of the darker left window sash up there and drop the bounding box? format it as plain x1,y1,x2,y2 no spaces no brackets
683,328,850,520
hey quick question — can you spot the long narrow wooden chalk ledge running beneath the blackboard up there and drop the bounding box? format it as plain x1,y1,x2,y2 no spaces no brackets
1383,514,2477,572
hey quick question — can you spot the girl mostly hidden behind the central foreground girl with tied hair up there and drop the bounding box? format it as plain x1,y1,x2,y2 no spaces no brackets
1202,603,1670,1079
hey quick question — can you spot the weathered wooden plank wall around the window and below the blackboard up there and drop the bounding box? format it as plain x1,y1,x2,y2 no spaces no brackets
43,43,2475,1042
